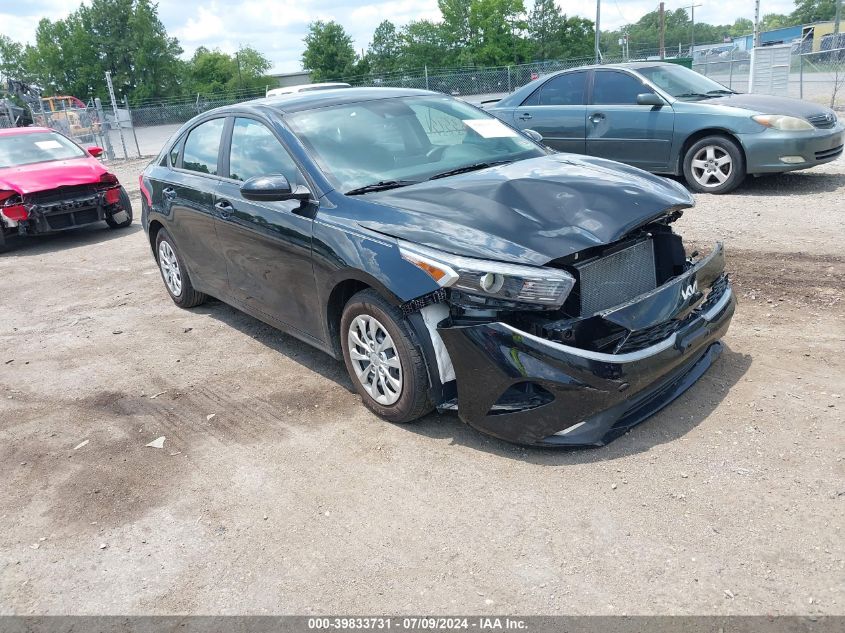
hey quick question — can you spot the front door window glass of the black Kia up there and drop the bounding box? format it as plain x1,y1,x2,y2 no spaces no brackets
229,118,299,185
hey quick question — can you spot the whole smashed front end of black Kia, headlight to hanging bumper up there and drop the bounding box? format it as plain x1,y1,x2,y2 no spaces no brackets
400,220,735,446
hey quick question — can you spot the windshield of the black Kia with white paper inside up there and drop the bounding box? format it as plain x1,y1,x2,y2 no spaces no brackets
286,96,545,192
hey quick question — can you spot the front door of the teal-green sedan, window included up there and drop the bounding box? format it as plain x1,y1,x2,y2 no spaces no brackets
586,70,675,171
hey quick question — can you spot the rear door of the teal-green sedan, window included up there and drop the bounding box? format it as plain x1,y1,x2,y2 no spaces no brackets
513,72,588,154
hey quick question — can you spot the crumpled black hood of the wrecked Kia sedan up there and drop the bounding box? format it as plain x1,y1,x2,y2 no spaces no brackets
359,154,695,265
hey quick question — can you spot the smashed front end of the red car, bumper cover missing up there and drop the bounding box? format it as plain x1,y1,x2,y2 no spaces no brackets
0,173,127,235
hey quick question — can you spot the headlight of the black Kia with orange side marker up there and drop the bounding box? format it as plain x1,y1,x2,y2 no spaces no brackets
399,242,575,308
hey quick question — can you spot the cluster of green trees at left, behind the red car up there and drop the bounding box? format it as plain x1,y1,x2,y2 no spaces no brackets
0,0,275,103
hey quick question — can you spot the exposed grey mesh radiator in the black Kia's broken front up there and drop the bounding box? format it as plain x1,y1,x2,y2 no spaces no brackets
574,238,657,316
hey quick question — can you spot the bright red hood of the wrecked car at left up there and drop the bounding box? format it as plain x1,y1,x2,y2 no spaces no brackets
0,158,108,195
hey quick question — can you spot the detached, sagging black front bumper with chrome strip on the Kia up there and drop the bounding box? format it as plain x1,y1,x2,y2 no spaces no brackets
438,249,736,446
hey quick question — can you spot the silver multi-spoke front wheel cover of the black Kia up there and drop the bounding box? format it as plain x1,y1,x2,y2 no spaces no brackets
346,314,402,405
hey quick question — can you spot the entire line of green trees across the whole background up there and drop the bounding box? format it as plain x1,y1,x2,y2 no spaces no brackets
0,0,836,103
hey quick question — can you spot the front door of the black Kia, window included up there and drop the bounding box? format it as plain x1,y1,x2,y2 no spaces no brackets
215,118,323,339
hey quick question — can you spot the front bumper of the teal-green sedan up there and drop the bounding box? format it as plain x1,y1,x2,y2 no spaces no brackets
739,122,845,174
